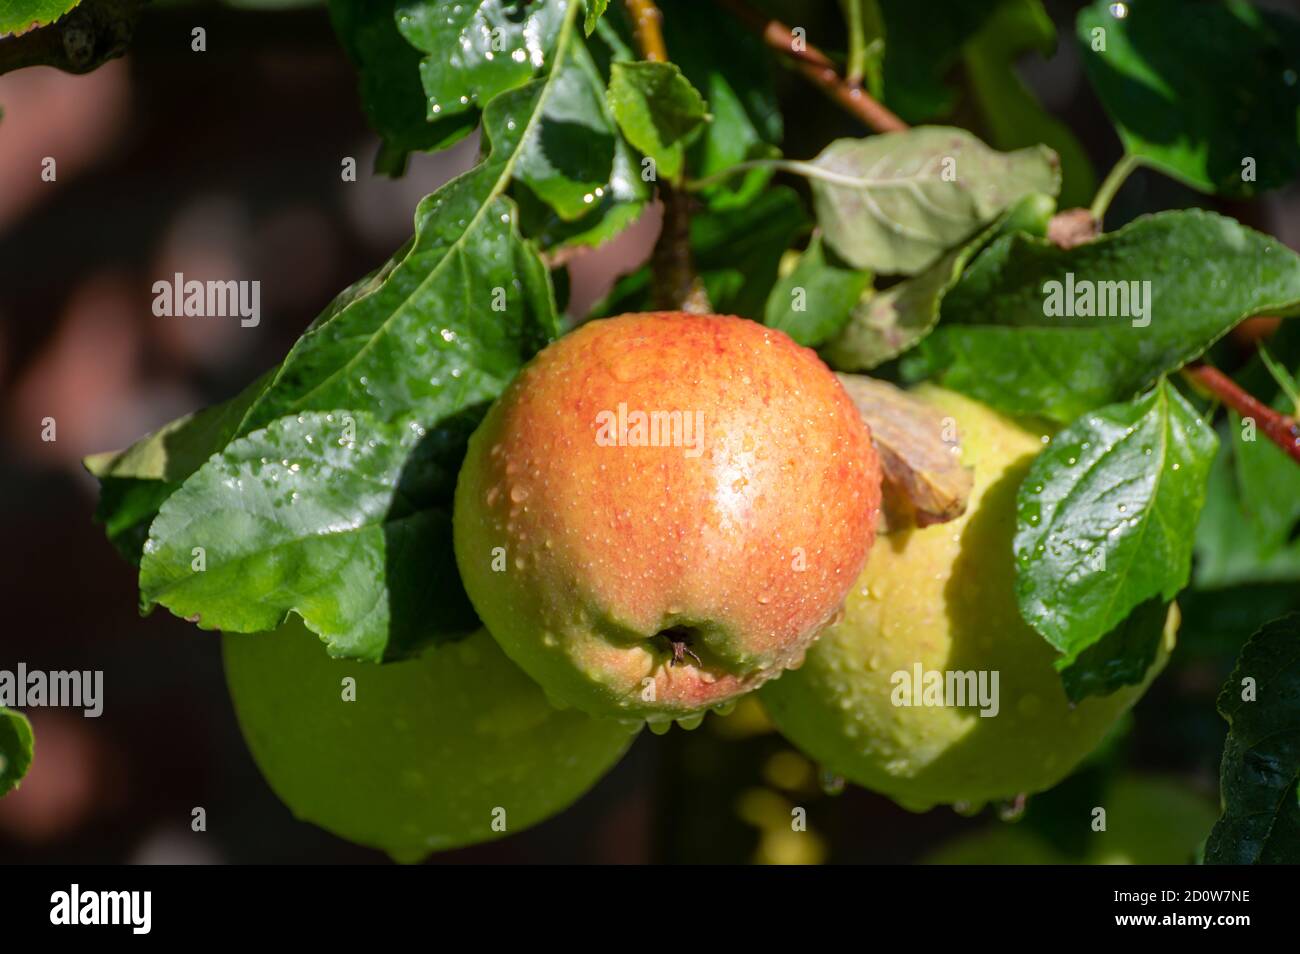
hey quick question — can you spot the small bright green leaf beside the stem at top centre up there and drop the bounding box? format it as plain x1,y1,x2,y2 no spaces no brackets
607,61,709,182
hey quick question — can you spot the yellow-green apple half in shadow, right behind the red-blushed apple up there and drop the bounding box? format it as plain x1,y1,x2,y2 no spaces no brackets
761,387,1177,811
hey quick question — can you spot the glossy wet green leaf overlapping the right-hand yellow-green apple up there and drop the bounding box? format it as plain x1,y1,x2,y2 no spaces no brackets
1014,381,1216,664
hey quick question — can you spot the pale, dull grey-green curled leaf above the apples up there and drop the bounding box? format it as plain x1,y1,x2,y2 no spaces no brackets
800,126,1060,274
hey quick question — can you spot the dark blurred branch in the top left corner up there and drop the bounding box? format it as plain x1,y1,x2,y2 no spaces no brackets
0,0,146,74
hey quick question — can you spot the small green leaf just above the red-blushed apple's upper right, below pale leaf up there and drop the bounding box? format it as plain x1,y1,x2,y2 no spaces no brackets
763,234,871,347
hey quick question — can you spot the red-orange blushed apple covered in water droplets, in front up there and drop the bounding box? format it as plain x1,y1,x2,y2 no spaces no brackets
454,312,880,723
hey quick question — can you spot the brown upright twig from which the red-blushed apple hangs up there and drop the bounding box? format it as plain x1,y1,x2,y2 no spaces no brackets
625,0,712,313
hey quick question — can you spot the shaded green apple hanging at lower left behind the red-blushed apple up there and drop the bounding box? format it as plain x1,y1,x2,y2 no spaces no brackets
222,617,632,862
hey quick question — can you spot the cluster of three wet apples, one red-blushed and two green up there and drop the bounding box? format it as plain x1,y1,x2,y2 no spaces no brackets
225,313,1174,859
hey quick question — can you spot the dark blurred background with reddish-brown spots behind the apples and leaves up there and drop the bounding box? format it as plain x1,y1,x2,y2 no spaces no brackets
0,3,1300,863
